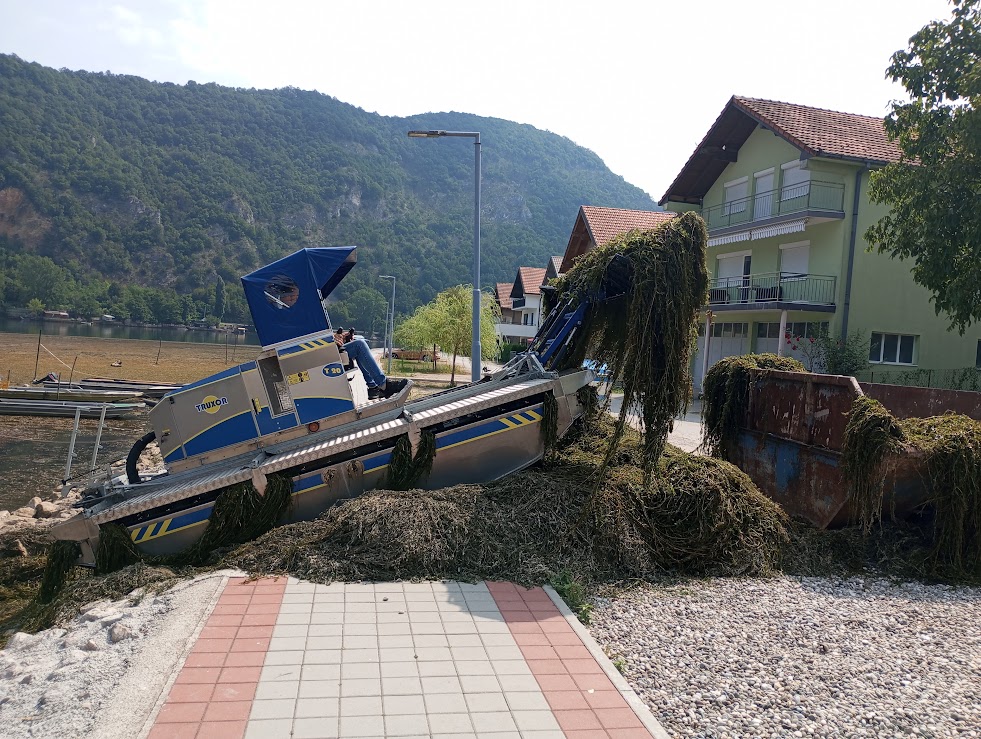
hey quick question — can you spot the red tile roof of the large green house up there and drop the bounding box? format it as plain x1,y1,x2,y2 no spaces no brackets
732,96,902,162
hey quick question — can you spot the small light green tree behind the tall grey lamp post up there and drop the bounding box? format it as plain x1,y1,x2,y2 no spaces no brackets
395,285,500,384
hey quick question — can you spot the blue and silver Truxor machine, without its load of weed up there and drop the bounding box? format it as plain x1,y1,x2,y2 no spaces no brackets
52,246,593,565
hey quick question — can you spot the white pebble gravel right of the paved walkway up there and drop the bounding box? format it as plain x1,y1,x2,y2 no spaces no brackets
589,578,981,737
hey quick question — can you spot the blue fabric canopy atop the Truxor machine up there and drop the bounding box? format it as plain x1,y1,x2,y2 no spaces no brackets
242,246,358,347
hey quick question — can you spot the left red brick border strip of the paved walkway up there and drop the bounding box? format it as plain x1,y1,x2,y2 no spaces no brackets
149,577,286,739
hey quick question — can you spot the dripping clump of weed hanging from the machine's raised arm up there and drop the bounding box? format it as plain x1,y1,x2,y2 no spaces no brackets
556,213,708,476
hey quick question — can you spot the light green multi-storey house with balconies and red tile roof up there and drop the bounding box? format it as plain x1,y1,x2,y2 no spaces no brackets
660,97,981,387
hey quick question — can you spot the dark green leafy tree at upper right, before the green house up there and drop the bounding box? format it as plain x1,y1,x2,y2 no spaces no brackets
865,0,981,334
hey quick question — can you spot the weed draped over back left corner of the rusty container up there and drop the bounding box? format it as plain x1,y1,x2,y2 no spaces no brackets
702,354,805,459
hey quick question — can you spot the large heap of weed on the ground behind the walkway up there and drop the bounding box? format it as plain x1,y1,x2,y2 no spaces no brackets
225,418,787,585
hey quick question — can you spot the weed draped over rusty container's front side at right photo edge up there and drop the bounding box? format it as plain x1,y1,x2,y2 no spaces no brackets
842,398,981,581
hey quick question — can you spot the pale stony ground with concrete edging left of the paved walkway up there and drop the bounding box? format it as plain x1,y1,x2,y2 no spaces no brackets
0,573,224,739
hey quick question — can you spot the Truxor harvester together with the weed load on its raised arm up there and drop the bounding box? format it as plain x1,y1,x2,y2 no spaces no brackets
52,214,706,571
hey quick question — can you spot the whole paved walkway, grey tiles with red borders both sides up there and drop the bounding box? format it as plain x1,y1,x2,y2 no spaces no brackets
144,578,667,739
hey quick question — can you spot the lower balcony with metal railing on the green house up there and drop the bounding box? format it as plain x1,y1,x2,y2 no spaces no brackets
708,272,838,313
